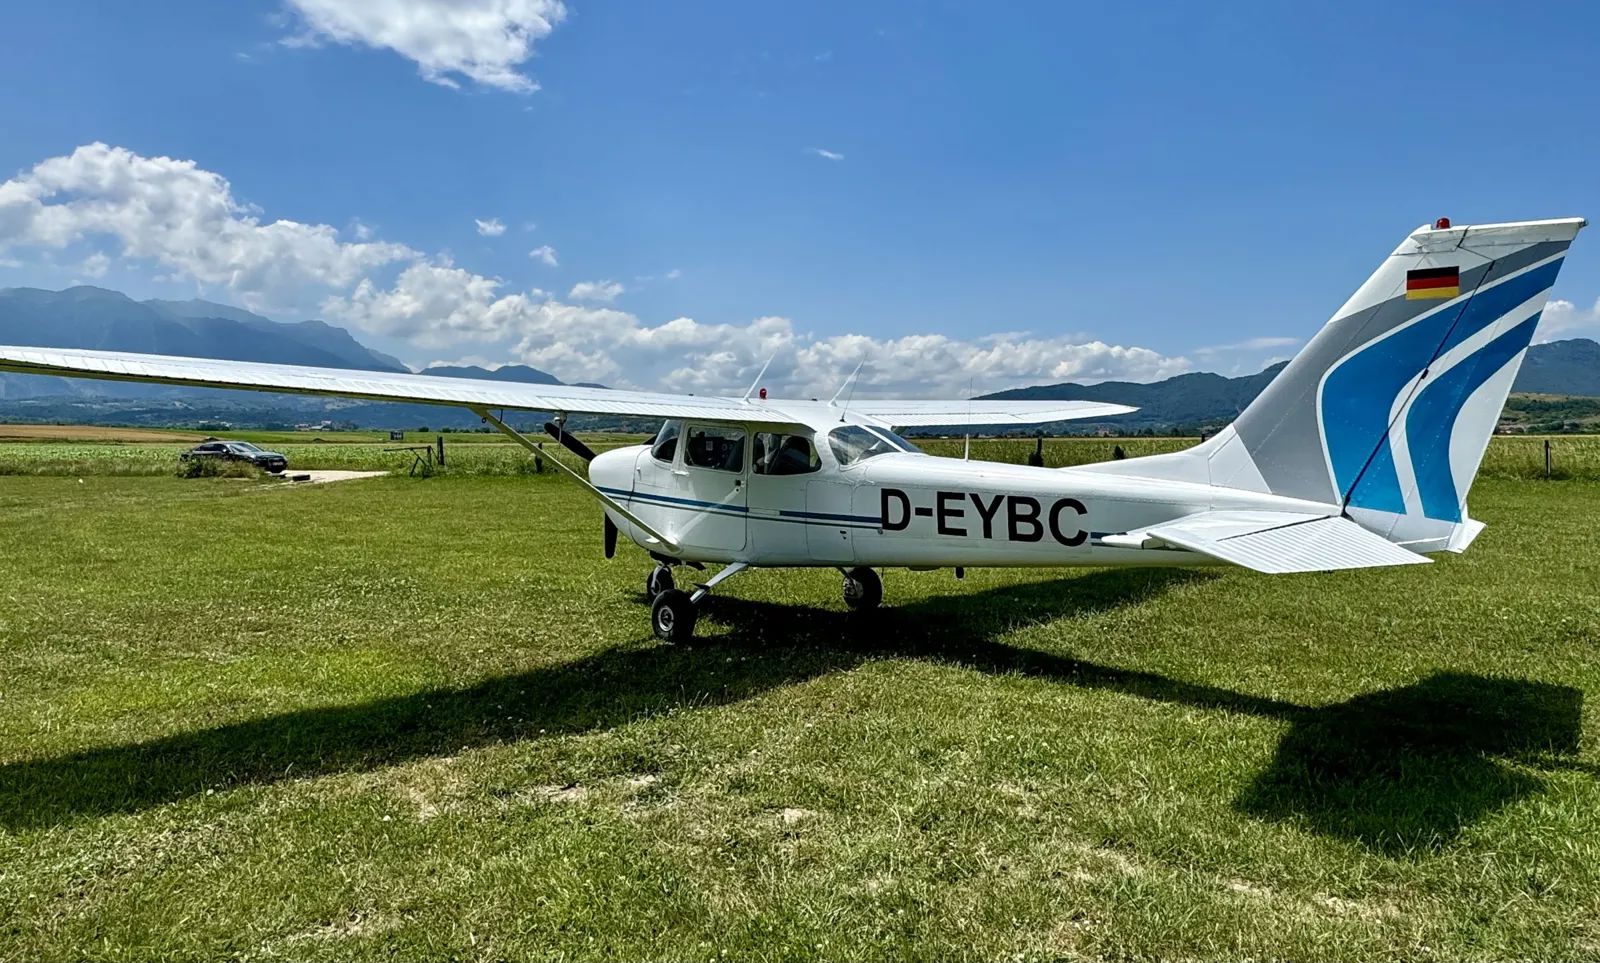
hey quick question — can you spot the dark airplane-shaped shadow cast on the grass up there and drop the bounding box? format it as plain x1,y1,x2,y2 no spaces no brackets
0,569,1587,854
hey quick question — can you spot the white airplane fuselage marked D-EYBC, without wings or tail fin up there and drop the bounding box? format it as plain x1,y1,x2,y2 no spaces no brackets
589,445,1326,568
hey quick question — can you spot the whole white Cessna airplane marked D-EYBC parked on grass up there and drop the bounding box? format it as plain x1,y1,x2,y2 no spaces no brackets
0,218,1584,641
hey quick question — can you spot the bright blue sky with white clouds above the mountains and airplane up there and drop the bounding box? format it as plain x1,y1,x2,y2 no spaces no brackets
0,0,1600,394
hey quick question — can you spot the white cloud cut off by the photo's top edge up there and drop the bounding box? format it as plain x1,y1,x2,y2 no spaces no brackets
285,0,566,93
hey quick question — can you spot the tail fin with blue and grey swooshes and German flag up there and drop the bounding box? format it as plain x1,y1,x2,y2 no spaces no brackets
1112,218,1584,550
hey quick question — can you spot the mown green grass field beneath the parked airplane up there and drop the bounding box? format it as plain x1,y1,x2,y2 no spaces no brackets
0,442,1600,960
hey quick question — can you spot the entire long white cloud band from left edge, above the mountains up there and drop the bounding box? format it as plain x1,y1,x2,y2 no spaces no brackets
0,144,1189,397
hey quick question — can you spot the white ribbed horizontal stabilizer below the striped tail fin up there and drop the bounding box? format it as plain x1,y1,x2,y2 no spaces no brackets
1130,512,1432,574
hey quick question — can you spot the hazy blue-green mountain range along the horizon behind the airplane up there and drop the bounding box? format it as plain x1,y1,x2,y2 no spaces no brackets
0,286,1600,430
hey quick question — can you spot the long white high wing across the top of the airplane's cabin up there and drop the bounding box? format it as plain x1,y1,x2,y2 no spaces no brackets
0,346,1134,426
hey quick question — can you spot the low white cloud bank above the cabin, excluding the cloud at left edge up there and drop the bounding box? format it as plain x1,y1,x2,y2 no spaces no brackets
323,264,1189,397
